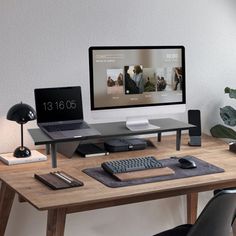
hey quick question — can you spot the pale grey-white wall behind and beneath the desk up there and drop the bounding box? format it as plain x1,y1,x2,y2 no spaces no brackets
0,0,236,236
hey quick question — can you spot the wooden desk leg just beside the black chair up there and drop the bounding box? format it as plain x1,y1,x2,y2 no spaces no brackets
187,193,198,224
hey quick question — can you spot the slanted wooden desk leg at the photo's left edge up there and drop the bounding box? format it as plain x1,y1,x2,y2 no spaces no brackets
0,182,15,236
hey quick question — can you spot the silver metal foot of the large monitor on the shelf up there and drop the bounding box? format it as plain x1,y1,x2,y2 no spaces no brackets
126,116,160,131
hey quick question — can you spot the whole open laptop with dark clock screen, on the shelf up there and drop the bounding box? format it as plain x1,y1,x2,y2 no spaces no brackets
34,86,101,140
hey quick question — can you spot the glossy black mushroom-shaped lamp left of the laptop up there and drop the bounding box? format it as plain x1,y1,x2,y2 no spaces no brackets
7,102,36,157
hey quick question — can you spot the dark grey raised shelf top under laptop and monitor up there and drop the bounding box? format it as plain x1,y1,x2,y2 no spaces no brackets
29,118,195,145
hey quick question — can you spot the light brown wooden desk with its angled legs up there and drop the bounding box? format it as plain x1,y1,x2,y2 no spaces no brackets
0,135,236,236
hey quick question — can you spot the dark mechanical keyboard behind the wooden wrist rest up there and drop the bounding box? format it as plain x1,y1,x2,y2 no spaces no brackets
101,156,163,174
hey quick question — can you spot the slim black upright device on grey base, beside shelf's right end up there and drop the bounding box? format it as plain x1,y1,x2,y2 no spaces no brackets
188,110,202,146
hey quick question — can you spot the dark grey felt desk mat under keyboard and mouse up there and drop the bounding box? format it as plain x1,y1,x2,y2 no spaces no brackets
83,156,224,188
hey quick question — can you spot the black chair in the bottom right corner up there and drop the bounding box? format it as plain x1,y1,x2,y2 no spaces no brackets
154,189,236,236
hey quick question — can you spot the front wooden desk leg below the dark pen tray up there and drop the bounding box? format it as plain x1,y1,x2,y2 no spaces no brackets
47,208,66,236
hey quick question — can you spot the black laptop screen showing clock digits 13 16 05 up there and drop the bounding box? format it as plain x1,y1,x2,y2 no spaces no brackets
34,86,83,123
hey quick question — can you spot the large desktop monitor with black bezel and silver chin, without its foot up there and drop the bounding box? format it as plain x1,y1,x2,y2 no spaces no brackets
89,46,186,121
